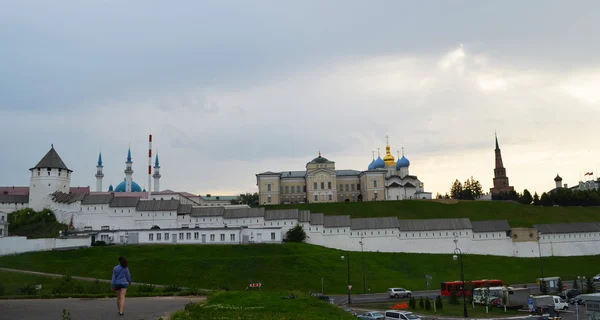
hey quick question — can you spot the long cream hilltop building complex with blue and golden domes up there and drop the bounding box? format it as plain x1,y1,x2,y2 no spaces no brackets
256,137,431,205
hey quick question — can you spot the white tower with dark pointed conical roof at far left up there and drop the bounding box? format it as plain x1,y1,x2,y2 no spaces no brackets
29,145,73,211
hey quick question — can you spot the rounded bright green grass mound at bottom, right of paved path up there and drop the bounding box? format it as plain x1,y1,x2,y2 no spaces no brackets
171,291,356,320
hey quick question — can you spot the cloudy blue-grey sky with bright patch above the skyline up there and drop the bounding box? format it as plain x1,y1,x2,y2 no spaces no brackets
0,0,600,196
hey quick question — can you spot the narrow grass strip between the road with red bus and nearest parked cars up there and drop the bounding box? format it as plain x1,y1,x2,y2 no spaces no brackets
351,299,527,318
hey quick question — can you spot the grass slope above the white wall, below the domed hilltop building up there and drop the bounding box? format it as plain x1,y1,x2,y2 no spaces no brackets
265,200,600,227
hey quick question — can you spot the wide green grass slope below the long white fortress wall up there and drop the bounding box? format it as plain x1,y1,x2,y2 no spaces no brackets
0,243,600,294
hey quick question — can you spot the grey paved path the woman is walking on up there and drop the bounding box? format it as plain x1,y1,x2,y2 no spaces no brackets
0,297,204,320
